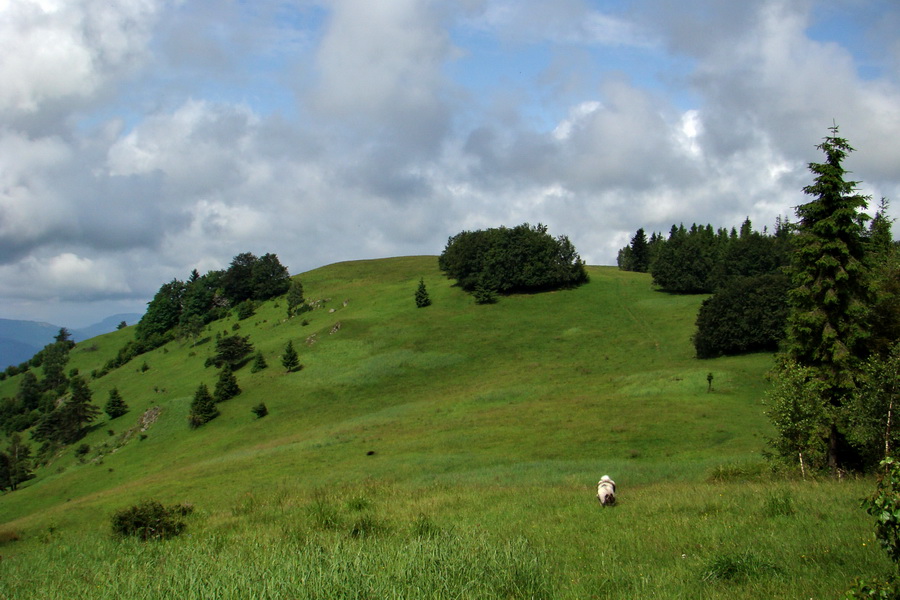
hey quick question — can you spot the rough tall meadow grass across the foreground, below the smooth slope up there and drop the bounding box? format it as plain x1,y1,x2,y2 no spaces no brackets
0,479,890,599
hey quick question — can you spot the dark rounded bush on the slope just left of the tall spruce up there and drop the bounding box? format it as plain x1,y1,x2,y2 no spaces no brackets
693,275,790,358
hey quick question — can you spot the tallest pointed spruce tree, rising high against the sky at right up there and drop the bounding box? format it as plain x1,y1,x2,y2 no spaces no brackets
772,126,872,472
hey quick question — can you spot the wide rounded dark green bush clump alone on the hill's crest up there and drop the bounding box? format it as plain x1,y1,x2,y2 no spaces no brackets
438,223,588,294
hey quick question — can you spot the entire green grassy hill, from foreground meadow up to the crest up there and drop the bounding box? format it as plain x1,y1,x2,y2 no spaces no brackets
0,257,888,598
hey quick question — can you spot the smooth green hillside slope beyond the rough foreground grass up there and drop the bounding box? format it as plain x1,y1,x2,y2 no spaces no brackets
0,257,768,519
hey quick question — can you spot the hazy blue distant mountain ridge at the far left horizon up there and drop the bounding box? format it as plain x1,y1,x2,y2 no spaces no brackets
0,313,141,370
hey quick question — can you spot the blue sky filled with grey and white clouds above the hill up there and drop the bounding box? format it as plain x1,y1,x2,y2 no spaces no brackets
0,0,900,327
